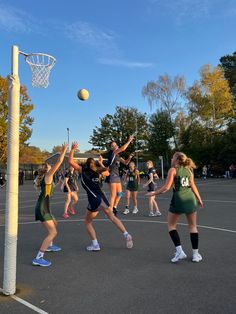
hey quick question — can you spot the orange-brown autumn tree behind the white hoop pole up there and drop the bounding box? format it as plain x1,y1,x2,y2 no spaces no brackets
0,76,34,164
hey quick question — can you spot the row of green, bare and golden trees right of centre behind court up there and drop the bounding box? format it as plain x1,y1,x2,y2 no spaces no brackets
90,52,236,174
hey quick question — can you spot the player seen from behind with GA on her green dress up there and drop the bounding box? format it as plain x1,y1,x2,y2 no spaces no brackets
147,152,203,263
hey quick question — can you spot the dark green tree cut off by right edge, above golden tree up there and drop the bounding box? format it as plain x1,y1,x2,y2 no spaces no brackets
220,51,236,101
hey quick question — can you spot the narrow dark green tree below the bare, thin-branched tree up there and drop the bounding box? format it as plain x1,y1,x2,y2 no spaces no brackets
148,111,175,163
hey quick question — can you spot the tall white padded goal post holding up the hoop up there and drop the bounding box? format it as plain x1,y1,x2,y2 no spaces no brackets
3,46,20,295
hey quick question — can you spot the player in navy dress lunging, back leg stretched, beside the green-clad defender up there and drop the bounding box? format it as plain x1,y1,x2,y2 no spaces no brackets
69,142,133,251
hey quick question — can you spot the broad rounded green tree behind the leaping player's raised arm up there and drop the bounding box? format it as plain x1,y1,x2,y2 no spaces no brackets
89,106,148,151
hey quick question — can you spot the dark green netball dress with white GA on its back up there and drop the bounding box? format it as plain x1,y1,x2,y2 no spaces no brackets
169,167,197,214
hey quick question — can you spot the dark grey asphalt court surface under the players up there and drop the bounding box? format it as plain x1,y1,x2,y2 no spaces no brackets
0,179,236,314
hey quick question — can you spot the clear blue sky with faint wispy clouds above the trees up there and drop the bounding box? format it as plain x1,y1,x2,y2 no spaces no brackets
0,0,236,151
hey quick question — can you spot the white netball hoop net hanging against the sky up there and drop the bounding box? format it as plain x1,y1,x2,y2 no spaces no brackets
25,53,56,88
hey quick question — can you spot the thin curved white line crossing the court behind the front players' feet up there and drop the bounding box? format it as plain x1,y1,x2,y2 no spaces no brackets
0,218,236,233
